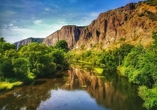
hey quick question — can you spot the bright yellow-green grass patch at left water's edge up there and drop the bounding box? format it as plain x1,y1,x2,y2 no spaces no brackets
0,81,23,90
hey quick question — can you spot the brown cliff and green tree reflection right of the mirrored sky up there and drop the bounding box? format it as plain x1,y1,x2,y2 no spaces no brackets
62,69,145,110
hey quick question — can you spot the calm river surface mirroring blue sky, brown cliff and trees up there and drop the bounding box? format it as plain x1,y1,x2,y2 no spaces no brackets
0,69,145,110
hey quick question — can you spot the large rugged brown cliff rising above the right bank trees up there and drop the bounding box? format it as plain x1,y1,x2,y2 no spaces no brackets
43,2,157,49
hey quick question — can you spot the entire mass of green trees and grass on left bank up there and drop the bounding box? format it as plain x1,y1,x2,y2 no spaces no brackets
0,38,68,89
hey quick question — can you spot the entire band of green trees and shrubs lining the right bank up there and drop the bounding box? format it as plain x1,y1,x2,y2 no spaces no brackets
68,32,157,109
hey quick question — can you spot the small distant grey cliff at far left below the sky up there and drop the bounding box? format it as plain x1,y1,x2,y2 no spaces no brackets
14,37,44,49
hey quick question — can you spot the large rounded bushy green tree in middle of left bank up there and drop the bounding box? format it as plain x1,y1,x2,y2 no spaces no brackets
18,43,55,77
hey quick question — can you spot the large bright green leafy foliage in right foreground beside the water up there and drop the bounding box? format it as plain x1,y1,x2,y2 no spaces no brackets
118,32,157,109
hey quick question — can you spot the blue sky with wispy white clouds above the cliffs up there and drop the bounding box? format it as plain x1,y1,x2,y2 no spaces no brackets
0,0,142,43
